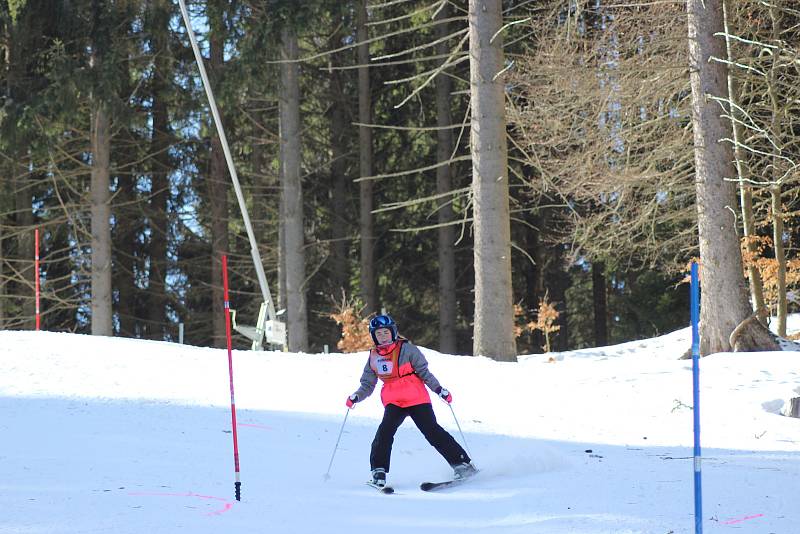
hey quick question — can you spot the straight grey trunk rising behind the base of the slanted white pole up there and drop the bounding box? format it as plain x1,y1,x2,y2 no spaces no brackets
280,25,308,352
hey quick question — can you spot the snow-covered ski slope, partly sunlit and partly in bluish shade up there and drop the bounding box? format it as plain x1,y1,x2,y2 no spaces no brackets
0,317,800,534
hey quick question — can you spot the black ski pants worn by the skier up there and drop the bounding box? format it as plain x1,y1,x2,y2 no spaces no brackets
369,402,471,473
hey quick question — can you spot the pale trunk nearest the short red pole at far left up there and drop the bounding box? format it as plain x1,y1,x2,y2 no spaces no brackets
91,101,114,336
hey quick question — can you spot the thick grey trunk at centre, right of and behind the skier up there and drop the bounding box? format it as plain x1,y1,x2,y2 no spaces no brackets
469,0,516,361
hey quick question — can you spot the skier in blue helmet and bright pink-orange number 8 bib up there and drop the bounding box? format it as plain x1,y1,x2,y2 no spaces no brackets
346,315,477,488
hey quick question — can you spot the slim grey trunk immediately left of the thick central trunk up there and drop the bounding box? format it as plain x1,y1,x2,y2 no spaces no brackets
436,4,457,354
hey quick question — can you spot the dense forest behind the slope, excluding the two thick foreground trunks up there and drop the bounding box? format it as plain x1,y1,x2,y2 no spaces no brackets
0,0,800,360
